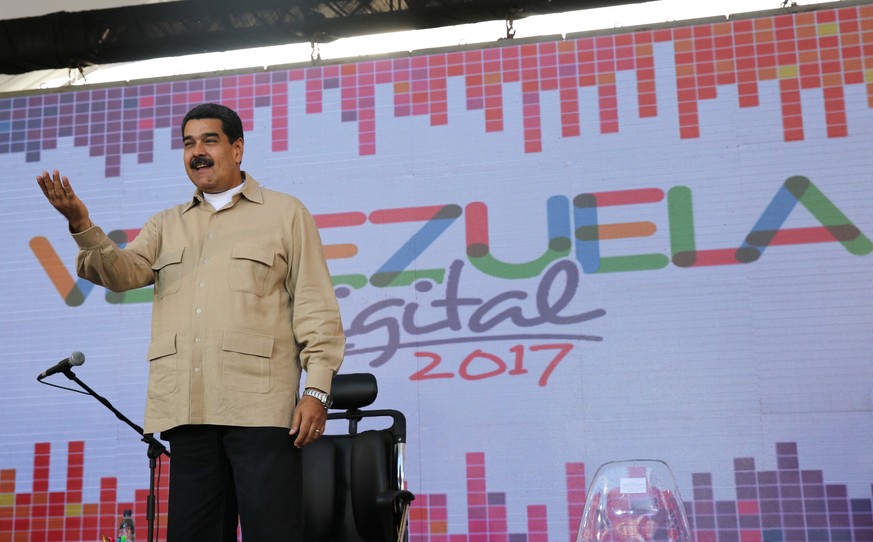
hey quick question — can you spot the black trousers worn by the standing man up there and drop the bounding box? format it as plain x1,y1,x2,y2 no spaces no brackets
161,425,303,542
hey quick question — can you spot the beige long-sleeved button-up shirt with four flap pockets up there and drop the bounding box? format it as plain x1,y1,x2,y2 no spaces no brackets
73,176,345,433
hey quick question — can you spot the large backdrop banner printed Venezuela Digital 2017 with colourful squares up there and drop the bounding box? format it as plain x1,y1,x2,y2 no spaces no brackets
0,2,873,542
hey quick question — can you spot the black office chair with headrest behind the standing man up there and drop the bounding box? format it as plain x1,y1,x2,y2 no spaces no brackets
303,373,415,542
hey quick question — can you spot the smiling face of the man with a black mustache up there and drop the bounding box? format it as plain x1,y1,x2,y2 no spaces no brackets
182,119,243,194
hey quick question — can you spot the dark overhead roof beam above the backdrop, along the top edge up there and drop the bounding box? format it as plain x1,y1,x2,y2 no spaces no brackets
0,0,648,75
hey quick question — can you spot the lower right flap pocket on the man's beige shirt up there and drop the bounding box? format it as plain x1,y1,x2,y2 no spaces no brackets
221,330,273,393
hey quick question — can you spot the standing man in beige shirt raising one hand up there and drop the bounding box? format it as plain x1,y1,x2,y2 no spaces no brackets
37,104,345,542
